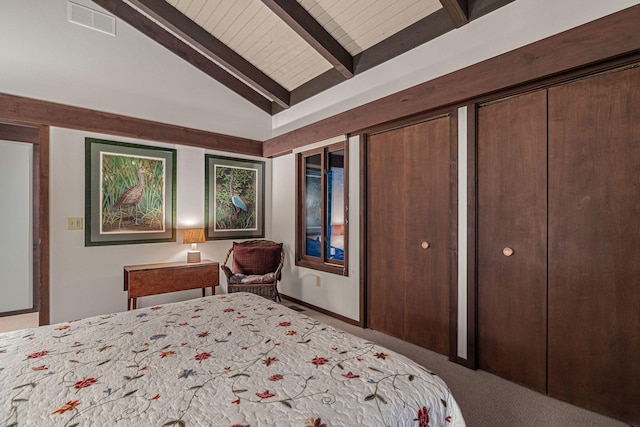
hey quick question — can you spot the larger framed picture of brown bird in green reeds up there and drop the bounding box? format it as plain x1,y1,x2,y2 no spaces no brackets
84,138,176,246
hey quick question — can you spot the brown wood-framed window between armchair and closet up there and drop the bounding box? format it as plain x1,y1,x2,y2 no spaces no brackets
296,141,348,276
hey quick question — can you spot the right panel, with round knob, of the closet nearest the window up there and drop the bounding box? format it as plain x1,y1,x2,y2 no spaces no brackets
403,117,451,354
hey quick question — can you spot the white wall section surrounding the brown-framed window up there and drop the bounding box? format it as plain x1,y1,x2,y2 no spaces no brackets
272,137,360,320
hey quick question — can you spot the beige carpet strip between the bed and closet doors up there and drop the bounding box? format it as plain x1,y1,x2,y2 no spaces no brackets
283,300,640,427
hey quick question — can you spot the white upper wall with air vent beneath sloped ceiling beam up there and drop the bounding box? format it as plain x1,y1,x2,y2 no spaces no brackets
0,0,271,140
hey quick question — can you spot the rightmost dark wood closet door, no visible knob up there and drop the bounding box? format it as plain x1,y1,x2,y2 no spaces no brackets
549,68,640,424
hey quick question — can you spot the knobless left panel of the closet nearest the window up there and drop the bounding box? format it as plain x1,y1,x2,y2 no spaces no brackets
367,130,410,338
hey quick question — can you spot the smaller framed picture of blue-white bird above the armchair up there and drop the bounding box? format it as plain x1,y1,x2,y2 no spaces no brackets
205,154,264,240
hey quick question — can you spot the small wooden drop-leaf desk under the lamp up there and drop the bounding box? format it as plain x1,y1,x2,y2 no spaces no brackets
124,259,220,310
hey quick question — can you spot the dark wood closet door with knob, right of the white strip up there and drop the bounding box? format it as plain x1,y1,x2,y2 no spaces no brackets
477,91,547,392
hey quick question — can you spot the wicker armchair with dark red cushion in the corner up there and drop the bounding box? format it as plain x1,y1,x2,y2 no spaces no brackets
220,240,284,301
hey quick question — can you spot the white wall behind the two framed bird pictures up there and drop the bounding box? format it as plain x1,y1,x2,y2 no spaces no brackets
49,128,272,323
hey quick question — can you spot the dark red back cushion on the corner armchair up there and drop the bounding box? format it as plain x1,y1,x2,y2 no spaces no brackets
232,242,282,275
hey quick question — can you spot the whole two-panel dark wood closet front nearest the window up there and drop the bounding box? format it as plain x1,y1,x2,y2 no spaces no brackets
367,117,450,354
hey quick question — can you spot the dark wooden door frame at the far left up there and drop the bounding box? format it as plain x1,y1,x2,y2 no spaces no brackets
0,122,49,325
